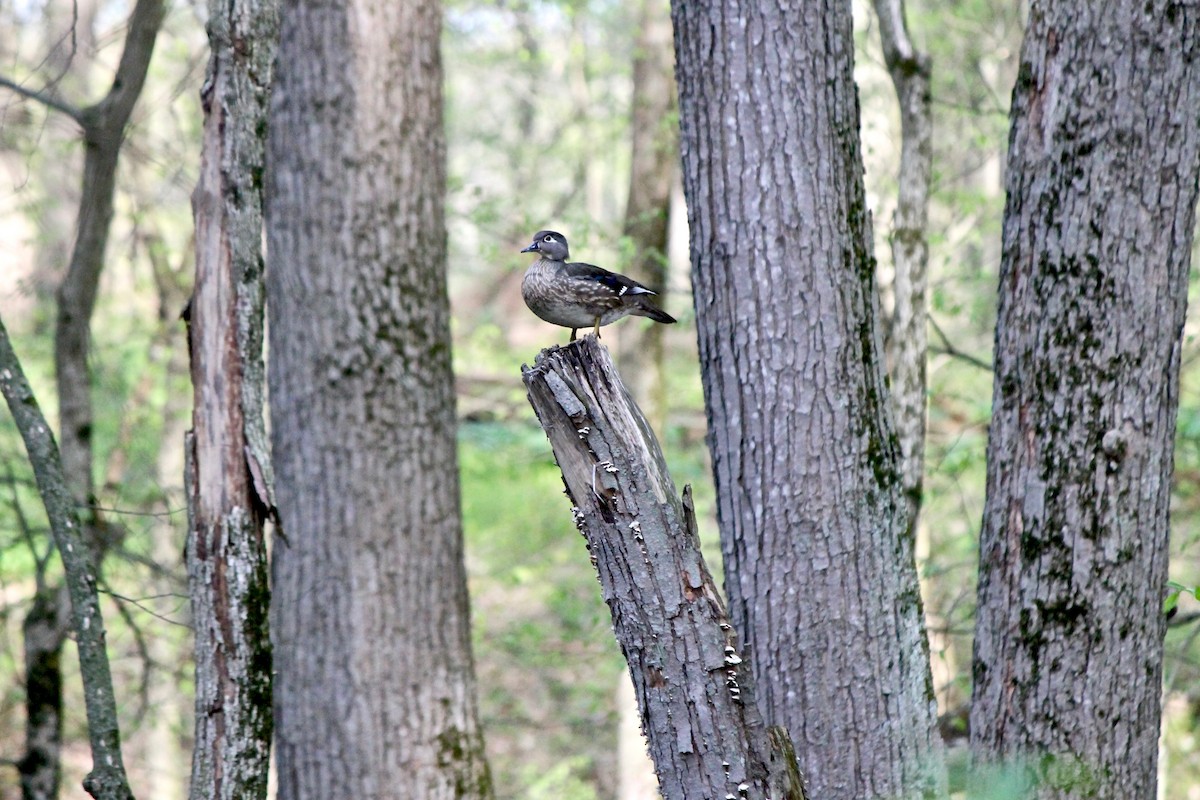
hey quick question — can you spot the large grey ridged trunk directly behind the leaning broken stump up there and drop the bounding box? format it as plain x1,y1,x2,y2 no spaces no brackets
673,0,942,799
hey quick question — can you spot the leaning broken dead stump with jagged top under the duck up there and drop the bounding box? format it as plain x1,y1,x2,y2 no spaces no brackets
522,336,805,800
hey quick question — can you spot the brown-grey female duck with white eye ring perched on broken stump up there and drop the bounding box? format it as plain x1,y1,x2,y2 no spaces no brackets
521,230,676,342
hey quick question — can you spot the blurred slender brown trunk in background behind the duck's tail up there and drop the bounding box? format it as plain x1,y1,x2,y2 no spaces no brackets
620,0,679,427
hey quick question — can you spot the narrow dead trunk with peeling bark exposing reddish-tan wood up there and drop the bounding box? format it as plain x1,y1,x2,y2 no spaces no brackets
185,0,278,786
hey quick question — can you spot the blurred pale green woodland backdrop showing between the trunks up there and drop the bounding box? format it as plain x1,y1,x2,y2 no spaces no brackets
0,0,1200,800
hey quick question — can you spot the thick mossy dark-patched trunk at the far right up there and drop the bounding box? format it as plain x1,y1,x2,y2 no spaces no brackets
971,0,1200,798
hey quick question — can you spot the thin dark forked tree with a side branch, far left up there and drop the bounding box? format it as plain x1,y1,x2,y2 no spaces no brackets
0,0,166,800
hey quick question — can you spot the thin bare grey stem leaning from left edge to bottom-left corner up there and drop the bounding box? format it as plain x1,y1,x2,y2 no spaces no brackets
0,321,133,800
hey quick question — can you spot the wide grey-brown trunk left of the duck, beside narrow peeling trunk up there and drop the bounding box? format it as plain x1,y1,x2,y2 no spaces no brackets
268,0,492,800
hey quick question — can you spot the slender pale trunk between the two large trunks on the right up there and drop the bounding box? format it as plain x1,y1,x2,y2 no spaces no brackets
874,0,934,528
